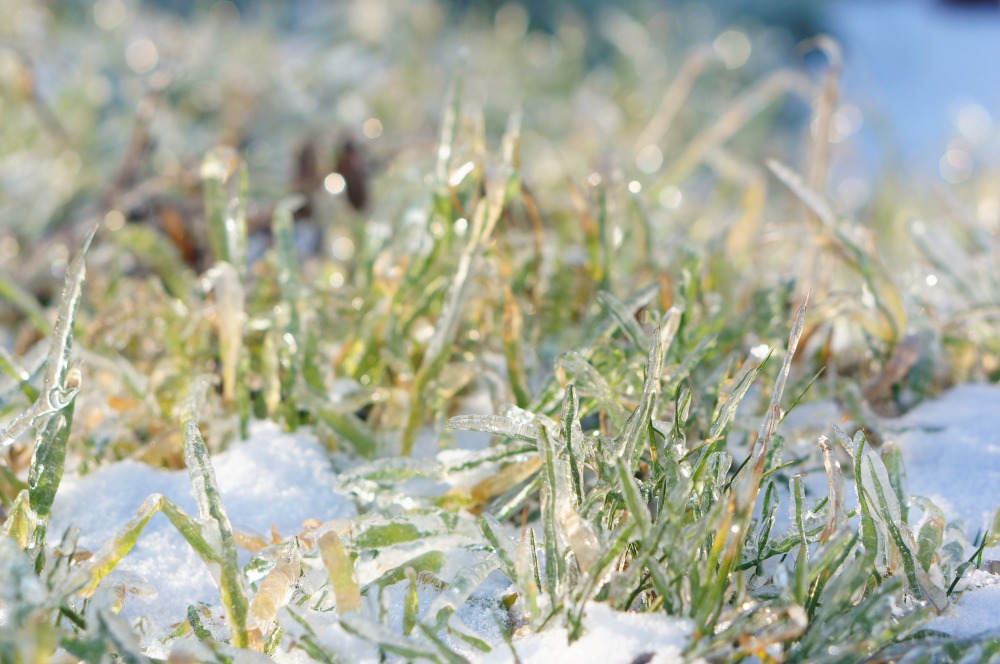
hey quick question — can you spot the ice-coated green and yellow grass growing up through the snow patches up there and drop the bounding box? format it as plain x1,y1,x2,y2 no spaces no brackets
0,2,1000,664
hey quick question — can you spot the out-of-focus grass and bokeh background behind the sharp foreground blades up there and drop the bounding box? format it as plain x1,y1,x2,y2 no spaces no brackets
0,0,1000,478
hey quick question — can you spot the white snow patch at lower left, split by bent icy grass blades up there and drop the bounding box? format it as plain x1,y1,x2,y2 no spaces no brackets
49,422,356,654
